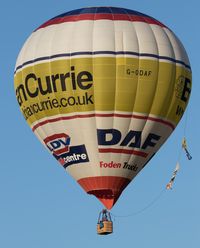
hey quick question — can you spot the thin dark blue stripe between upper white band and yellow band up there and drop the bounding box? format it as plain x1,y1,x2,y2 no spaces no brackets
14,51,191,74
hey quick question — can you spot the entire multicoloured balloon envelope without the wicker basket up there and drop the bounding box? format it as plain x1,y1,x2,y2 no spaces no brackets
14,7,191,217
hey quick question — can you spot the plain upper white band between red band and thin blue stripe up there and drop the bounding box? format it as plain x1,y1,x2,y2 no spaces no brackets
16,20,189,70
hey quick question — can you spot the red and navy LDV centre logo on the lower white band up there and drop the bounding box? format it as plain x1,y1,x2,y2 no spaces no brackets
44,133,89,168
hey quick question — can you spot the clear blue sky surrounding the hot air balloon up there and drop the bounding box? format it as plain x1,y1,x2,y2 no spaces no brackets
0,0,200,248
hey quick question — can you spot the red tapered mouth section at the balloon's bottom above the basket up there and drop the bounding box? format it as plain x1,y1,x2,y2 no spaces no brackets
78,176,130,209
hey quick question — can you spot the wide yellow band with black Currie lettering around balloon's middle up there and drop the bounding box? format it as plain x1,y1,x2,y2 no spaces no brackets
15,57,191,124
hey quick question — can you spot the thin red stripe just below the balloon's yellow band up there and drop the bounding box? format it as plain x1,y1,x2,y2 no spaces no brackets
32,113,175,132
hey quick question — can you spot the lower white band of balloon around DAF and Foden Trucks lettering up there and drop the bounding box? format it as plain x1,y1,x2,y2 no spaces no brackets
32,112,172,180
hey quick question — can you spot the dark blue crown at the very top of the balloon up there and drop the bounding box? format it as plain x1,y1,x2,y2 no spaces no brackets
51,7,151,20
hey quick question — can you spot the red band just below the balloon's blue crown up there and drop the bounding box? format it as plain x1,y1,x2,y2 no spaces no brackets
36,14,166,30
